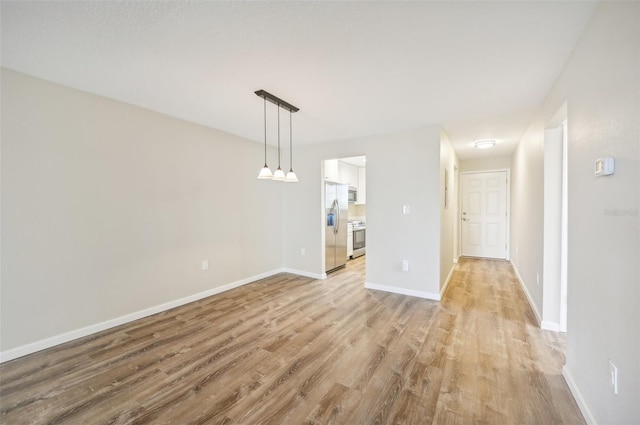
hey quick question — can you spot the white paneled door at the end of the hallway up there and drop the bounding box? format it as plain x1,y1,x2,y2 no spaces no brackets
461,171,507,259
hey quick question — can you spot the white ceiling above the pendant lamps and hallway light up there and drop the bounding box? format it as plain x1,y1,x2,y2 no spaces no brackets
0,1,594,159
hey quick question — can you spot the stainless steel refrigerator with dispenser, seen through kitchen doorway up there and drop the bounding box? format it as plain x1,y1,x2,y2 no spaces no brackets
324,182,349,273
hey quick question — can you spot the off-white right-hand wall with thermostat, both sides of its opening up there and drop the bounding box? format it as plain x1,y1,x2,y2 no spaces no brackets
511,2,640,425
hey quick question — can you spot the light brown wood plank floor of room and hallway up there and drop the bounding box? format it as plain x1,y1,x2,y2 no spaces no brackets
0,258,584,425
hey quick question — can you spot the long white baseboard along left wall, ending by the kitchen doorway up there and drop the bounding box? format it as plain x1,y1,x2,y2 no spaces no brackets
0,269,286,363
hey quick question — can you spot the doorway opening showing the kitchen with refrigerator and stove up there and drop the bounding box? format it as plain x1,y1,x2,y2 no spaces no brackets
322,155,367,273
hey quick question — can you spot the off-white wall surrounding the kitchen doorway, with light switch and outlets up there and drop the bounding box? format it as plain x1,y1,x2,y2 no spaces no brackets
283,126,440,299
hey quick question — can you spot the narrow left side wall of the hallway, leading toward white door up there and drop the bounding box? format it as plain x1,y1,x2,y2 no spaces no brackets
440,131,459,293
